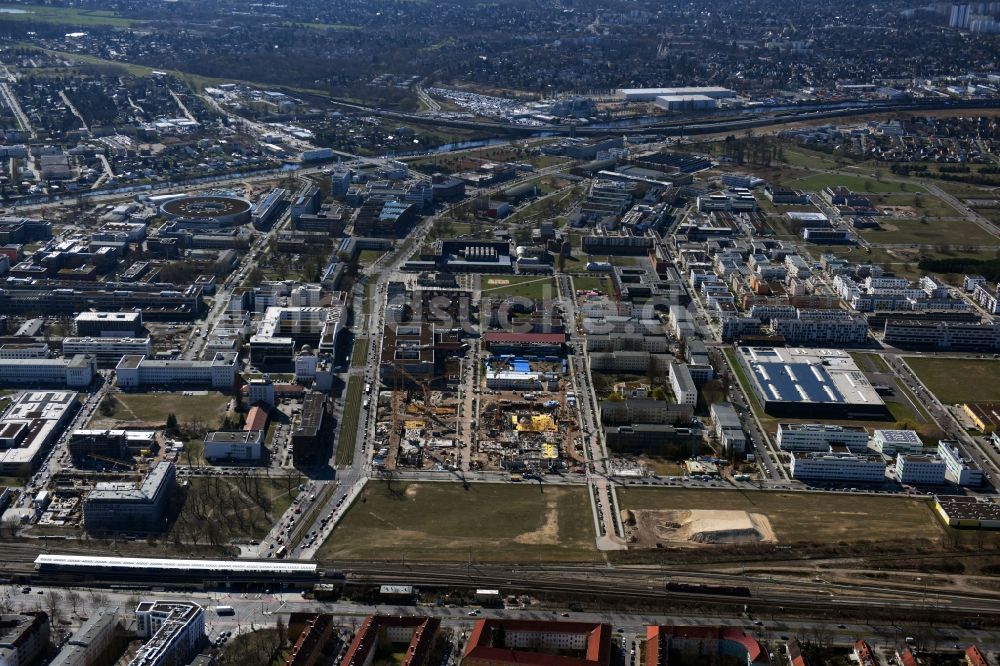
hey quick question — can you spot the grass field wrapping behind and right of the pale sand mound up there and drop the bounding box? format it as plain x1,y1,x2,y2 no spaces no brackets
618,488,943,545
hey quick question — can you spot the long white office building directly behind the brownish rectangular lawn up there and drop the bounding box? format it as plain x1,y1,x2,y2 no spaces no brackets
115,352,237,391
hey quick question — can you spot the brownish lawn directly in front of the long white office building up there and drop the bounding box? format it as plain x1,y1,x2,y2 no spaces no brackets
102,391,232,428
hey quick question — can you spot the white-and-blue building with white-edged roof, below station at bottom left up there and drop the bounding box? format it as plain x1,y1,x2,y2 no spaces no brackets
129,600,205,666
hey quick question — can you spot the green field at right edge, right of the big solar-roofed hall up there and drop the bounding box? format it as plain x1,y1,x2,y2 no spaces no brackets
905,356,1000,405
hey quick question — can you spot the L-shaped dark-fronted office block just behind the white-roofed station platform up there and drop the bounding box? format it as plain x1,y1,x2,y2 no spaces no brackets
83,461,176,532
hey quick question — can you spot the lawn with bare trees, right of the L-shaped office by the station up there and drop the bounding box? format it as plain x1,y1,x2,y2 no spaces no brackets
170,476,299,545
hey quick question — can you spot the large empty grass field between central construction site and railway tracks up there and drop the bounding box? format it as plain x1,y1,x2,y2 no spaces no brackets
317,480,597,562
